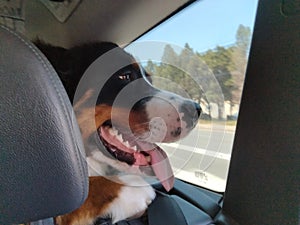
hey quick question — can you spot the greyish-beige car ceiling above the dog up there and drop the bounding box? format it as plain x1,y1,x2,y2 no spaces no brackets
24,0,190,47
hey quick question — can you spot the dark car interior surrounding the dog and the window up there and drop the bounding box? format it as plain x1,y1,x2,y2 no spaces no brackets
0,0,300,225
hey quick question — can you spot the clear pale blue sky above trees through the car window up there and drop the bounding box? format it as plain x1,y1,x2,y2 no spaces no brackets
139,0,257,52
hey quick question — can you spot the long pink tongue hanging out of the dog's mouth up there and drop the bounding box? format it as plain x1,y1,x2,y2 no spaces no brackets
142,146,174,191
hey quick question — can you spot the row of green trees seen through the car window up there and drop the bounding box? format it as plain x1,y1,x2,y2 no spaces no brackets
146,25,251,118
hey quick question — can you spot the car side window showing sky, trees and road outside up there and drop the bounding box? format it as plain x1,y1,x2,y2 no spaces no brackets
125,0,257,192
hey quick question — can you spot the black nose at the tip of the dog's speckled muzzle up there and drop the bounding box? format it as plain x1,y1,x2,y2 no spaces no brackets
180,101,201,127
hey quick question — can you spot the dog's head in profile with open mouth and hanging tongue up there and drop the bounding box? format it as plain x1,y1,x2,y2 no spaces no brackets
75,43,201,190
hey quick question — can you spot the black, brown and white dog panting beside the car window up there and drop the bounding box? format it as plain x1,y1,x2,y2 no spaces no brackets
34,40,201,225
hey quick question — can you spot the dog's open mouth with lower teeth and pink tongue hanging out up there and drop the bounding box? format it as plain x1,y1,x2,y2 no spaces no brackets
98,122,174,191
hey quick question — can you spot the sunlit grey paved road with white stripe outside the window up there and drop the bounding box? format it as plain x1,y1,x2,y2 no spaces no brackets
162,126,234,191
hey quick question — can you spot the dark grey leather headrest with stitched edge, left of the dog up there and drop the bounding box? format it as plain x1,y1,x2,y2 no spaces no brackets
0,26,88,224
